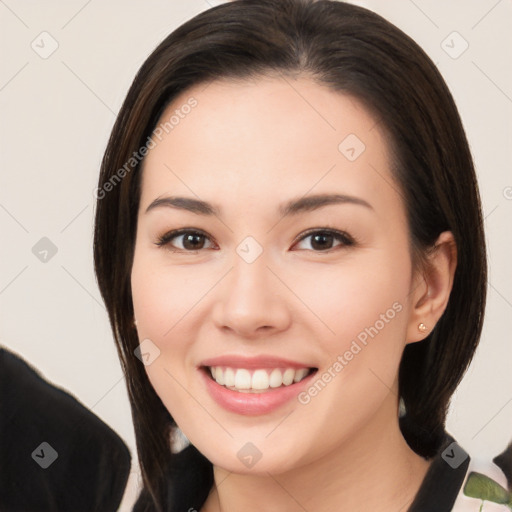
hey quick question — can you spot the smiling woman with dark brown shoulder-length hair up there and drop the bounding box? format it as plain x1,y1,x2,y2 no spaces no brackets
94,0,486,512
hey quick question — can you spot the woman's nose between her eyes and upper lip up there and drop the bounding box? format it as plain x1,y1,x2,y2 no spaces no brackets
214,252,292,338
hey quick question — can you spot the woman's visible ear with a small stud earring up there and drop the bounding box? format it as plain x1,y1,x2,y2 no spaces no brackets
407,231,457,343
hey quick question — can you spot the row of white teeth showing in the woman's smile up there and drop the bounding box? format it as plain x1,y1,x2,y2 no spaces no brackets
202,366,317,393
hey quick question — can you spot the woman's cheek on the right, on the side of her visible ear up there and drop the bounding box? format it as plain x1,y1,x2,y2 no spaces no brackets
302,252,410,418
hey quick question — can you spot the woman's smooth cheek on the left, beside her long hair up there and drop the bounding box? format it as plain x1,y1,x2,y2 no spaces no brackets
131,247,215,396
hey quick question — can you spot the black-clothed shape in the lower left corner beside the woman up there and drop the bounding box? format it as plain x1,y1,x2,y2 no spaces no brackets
0,347,131,512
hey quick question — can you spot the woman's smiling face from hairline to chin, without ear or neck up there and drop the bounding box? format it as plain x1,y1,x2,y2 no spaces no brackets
131,78,420,473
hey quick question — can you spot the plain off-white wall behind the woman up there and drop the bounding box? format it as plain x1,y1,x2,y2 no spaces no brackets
0,0,512,510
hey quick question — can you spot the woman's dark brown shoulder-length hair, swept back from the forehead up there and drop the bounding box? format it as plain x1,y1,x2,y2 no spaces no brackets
94,0,487,510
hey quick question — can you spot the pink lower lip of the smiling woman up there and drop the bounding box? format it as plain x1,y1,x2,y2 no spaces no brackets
199,369,316,416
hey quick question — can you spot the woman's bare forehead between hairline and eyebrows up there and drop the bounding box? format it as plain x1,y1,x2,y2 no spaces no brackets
141,76,400,218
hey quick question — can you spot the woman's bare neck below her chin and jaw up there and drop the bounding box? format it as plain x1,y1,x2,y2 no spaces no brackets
202,396,431,512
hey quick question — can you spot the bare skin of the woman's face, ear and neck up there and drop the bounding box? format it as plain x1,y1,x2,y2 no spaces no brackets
131,76,456,512
